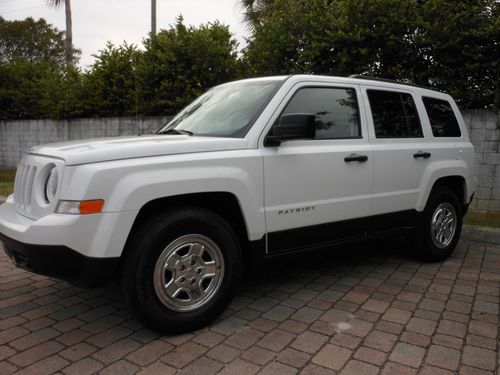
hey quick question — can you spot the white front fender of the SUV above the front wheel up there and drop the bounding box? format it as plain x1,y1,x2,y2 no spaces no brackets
61,150,265,240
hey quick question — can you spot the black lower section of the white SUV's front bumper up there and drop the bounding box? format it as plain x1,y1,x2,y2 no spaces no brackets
0,233,120,288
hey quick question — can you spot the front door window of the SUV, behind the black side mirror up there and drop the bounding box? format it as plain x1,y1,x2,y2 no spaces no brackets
282,87,361,139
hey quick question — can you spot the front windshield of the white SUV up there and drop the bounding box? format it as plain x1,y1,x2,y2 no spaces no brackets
158,80,282,138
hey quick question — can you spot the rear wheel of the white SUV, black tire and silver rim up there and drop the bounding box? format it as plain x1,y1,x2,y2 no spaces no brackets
413,186,463,262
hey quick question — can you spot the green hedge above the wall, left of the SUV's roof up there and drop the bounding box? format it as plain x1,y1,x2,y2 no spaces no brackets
0,18,240,119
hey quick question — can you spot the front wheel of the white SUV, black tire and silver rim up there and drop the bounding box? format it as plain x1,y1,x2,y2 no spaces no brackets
121,208,241,333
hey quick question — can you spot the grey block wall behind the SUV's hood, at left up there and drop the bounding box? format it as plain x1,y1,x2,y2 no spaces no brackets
0,116,170,168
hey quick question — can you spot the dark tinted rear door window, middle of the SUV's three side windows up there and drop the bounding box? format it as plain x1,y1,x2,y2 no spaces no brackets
367,90,423,138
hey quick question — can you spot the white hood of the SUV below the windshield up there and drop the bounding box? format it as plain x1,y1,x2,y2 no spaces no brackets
29,134,247,165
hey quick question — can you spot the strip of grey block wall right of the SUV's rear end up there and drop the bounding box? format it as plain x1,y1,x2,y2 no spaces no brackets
462,110,500,223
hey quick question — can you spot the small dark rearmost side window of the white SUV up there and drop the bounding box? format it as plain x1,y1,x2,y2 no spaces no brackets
422,97,462,137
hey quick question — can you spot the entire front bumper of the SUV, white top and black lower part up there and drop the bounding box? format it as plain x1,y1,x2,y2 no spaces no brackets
0,196,137,287
